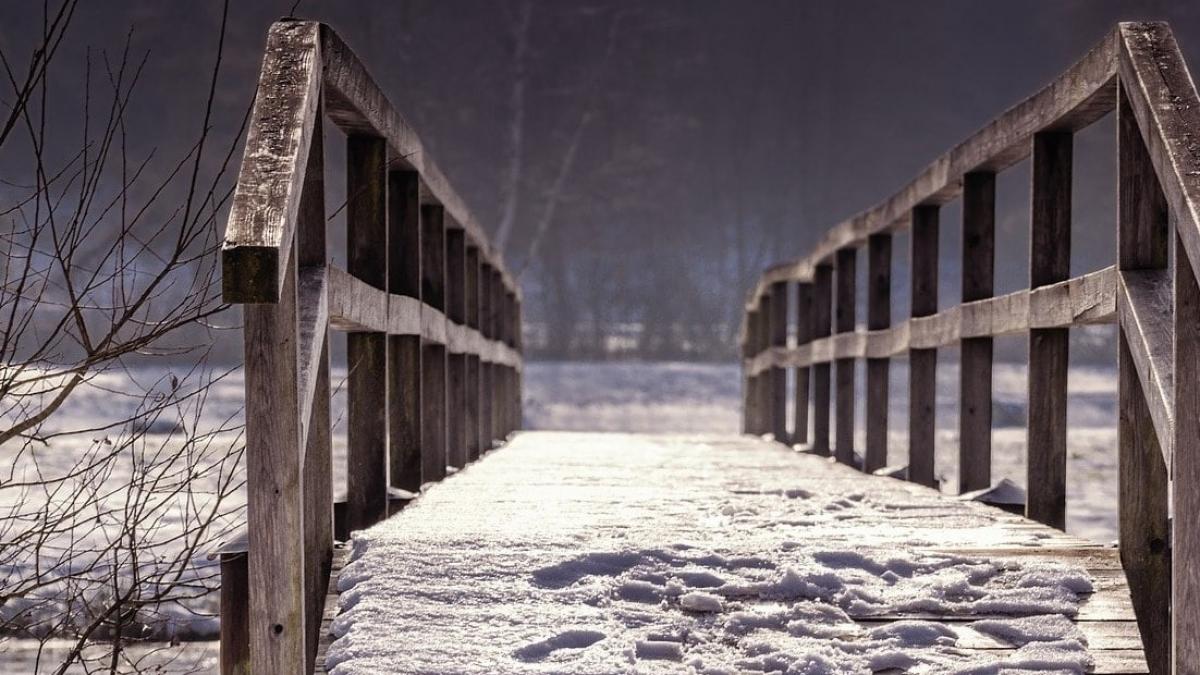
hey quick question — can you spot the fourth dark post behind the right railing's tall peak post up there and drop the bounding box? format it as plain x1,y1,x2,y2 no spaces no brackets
863,232,892,473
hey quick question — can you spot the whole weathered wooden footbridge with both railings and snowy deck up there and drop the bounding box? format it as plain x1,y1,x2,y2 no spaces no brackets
221,22,1200,674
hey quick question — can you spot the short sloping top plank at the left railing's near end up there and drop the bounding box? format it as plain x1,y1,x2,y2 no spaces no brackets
221,22,322,303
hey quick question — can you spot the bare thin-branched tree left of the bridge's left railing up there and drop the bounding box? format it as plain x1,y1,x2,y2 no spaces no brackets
0,0,248,673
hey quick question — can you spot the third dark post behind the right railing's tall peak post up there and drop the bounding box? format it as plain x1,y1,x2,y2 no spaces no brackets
908,204,938,488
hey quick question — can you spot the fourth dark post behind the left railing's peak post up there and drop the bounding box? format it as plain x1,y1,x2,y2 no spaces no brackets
446,227,467,468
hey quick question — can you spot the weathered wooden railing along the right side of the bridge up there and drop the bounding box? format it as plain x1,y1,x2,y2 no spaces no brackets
743,23,1200,674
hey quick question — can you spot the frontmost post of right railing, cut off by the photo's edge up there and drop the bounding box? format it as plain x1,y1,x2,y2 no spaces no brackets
1171,229,1200,674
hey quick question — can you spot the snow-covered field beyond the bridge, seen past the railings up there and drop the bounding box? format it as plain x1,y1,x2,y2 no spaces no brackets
0,362,1116,673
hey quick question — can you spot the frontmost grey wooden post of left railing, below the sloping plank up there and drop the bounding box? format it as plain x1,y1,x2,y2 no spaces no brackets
242,256,307,673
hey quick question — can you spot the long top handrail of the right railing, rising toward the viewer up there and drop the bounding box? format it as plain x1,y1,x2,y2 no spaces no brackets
748,24,1118,305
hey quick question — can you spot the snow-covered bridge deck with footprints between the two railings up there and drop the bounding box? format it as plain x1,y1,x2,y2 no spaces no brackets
322,432,1146,675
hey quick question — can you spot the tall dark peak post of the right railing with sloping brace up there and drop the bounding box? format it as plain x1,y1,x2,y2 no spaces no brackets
1117,77,1181,673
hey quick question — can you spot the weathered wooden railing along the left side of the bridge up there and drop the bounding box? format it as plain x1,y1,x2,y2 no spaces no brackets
214,20,522,674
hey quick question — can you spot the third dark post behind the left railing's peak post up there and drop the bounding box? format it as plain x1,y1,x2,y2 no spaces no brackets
421,204,446,483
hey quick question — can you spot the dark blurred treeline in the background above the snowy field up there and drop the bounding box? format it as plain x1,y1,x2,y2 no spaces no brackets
0,0,1200,359
